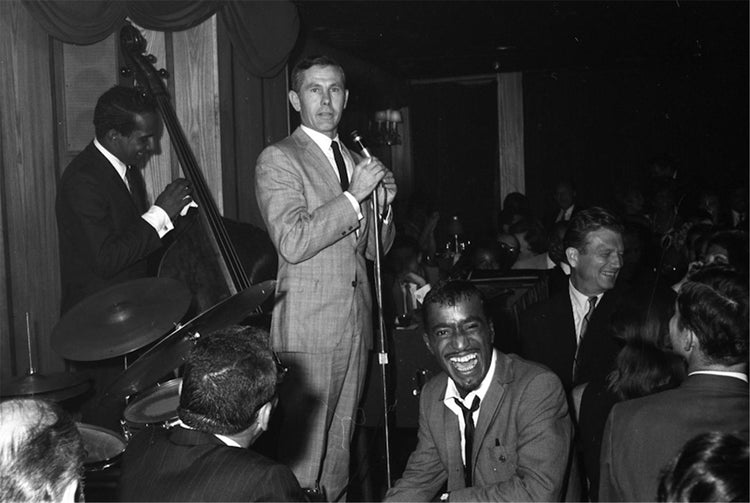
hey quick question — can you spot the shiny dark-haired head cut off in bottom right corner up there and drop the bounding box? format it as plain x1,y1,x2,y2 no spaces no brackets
657,432,749,502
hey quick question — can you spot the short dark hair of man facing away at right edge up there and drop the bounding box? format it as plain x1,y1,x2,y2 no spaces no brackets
677,265,748,365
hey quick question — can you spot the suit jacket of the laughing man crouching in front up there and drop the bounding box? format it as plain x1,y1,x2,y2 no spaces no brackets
386,351,572,501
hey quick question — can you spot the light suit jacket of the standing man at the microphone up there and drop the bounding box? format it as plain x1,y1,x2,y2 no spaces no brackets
255,128,394,353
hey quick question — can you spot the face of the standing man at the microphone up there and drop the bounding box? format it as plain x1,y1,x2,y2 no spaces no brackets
289,65,349,138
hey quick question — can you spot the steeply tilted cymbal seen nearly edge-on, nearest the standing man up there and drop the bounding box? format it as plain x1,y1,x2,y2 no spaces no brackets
102,280,276,401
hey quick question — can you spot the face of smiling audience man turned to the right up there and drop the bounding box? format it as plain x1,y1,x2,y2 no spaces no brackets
565,227,624,295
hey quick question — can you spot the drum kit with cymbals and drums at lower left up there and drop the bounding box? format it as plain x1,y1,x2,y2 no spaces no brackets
0,278,275,473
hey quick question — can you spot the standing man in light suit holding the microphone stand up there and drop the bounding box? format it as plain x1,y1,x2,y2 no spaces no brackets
255,56,396,499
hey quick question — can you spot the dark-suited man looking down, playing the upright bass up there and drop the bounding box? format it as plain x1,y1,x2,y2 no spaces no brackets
56,86,191,314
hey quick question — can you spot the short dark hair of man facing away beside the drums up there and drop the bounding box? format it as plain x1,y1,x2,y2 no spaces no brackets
177,326,278,435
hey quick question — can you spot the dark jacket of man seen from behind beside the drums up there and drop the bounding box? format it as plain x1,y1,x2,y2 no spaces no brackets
119,426,305,501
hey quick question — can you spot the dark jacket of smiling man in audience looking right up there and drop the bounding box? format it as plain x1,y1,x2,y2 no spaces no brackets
520,288,620,390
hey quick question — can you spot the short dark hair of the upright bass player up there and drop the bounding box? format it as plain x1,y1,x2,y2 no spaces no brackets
94,86,157,140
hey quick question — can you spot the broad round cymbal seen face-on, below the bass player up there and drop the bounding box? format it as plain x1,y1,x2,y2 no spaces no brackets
52,278,191,361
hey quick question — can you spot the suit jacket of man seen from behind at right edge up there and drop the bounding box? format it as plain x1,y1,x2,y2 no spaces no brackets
599,374,749,501
